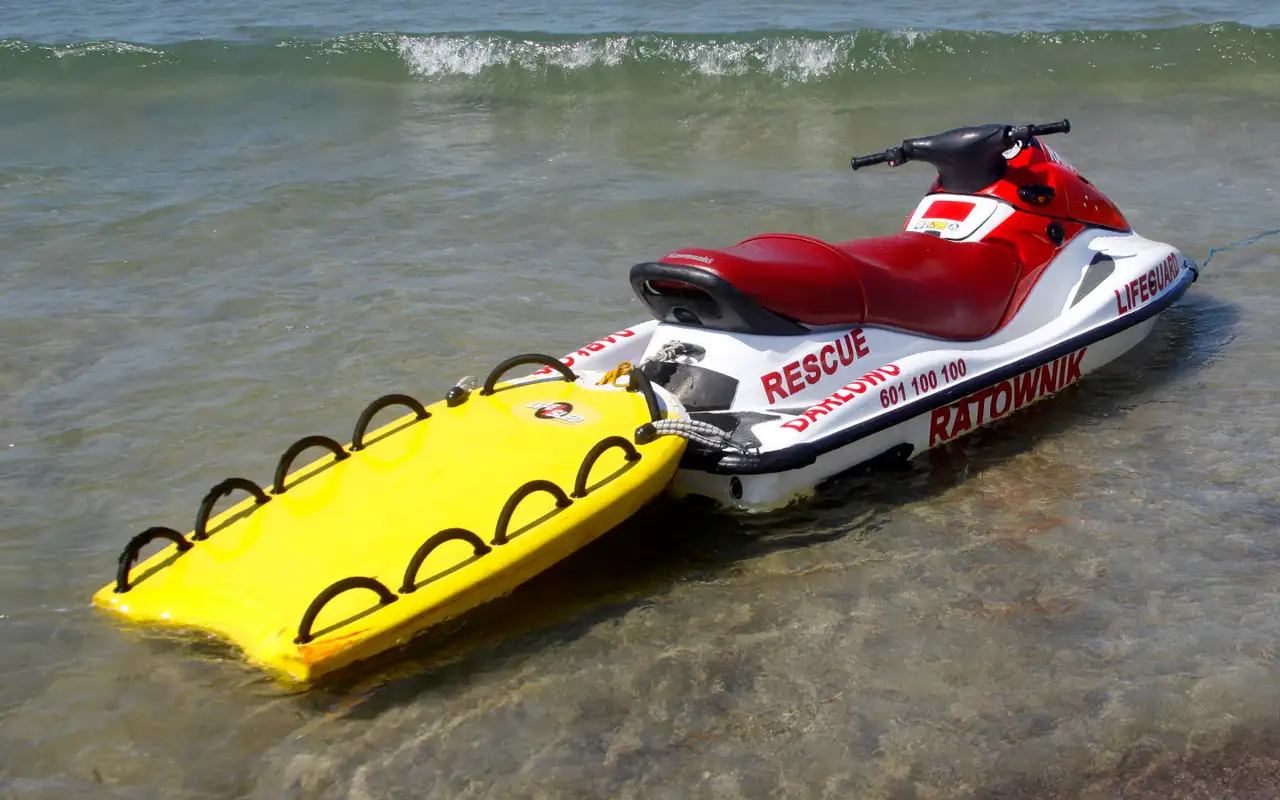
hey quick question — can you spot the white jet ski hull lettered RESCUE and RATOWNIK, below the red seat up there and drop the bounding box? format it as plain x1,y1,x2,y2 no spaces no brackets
535,229,1197,512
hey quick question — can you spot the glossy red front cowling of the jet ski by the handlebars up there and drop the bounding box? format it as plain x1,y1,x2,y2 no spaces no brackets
977,141,1129,230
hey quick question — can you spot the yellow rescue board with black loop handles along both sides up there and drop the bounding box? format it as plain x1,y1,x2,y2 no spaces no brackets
93,357,685,682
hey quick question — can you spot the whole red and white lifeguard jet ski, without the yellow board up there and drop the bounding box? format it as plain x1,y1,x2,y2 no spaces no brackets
522,119,1198,511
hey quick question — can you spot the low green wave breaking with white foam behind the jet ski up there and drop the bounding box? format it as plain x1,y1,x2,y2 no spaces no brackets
0,23,1280,83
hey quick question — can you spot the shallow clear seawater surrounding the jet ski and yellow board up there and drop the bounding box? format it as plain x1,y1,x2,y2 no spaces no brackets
0,4,1280,797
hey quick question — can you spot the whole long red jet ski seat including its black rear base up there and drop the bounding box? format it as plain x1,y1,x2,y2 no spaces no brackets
631,232,1023,340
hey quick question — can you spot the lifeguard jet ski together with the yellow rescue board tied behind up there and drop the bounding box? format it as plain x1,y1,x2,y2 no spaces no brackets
93,119,1198,682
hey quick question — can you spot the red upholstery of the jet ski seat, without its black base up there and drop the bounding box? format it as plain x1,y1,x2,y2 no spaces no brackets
662,233,1021,340
